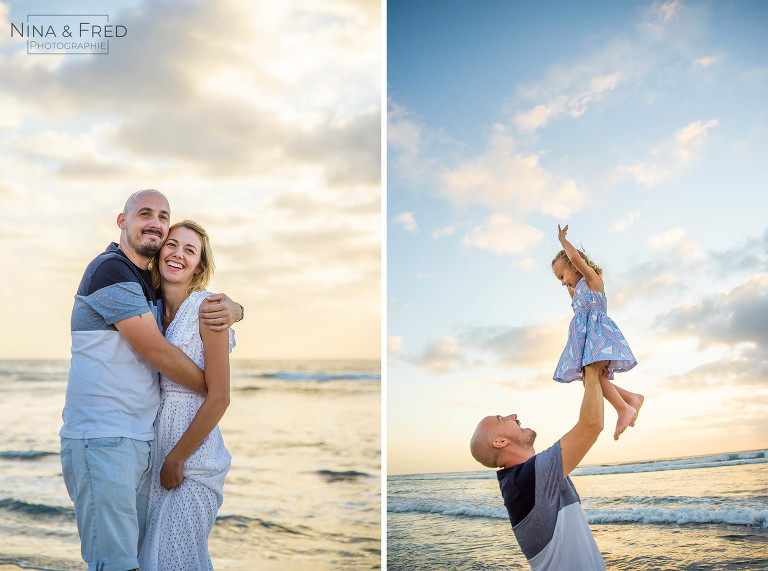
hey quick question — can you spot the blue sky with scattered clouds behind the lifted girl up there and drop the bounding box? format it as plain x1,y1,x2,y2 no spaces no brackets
387,1,768,473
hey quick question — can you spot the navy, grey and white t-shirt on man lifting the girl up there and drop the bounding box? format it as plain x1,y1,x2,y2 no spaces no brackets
497,441,605,571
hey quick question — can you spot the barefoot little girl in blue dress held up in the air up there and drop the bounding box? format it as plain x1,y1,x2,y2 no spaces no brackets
552,224,644,440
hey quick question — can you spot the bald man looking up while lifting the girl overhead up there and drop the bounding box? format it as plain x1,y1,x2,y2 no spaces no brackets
470,362,606,571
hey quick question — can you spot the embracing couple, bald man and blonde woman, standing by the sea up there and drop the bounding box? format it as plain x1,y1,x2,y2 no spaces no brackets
59,190,243,571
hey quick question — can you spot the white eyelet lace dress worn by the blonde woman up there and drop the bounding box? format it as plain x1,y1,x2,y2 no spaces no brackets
139,292,235,571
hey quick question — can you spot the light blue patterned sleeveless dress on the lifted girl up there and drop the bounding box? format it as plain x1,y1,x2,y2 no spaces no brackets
554,278,637,383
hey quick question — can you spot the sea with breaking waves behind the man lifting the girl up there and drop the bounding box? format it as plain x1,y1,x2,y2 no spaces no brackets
387,450,768,571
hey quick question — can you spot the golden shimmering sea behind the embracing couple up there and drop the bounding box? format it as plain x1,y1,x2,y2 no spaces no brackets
0,360,382,571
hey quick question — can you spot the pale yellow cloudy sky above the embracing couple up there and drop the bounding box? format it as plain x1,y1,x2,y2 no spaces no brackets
0,0,383,359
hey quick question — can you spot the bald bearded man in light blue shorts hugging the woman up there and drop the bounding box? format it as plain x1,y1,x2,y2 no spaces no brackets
59,189,243,571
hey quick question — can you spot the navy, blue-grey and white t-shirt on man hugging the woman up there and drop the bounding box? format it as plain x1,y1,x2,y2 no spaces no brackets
59,243,161,440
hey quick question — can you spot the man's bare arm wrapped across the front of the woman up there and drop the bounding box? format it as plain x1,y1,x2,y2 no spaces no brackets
115,312,208,395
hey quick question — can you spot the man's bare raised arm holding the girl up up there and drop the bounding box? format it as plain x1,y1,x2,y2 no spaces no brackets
560,361,607,478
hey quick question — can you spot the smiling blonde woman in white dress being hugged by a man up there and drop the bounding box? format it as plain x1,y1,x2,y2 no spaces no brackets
139,220,235,571
